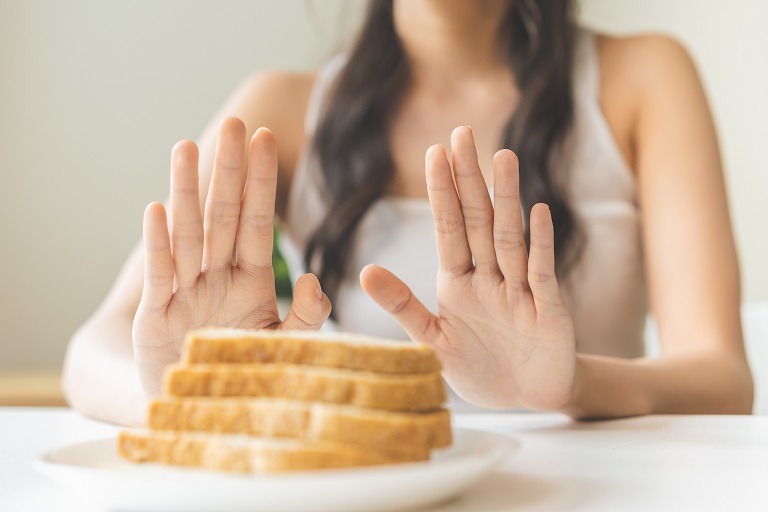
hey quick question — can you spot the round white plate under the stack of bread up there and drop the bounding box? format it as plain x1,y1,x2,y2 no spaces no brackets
35,428,518,512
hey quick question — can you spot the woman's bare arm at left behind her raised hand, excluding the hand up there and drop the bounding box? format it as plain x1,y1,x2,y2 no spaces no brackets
62,73,313,424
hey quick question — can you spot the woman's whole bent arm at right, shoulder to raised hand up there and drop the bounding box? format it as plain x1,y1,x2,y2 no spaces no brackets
361,37,752,418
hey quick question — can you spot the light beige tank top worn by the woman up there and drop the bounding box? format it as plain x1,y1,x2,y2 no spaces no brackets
280,30,647,364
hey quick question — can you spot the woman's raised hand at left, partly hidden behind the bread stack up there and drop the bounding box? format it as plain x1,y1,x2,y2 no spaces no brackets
133,118,331,395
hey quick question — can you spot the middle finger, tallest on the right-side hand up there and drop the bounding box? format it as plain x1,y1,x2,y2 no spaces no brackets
451,126,501,275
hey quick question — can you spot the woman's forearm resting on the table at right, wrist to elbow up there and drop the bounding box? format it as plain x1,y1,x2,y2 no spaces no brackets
564,354,753,419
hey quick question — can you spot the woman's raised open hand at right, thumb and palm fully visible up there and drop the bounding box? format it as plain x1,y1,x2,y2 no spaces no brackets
360,127,576,410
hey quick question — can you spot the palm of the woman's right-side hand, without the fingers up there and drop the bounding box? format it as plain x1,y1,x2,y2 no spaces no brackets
433,277,575,409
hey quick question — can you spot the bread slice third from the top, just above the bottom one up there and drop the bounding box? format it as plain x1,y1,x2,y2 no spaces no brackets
147,397,451,457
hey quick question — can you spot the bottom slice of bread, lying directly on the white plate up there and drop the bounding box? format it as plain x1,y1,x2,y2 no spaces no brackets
118,431,428,473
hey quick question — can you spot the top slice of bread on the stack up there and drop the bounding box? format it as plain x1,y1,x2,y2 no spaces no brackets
182,328,440,374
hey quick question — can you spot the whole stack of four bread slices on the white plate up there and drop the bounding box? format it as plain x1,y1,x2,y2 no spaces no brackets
119,328,451,473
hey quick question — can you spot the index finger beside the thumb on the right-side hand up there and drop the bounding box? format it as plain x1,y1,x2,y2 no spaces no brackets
425,144,472,275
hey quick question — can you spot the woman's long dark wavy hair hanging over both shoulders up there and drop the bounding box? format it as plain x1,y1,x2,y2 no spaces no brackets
304,0,581,308
